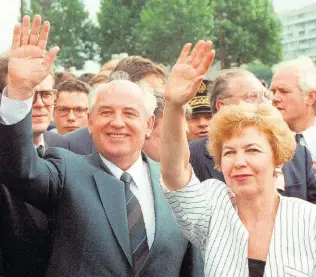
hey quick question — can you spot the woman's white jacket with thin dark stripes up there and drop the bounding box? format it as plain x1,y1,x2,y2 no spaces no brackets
161,173,316,277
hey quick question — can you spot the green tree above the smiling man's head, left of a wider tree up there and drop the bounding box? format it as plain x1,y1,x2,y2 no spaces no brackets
97,0,146,61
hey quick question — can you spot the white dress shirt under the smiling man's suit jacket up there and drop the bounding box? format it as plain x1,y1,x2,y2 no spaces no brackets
100,155,155,249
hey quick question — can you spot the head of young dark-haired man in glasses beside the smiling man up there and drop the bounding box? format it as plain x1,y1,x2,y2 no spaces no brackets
54,80,90,135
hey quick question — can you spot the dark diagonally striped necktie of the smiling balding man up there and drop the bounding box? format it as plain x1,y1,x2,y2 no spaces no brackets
121,172,149,273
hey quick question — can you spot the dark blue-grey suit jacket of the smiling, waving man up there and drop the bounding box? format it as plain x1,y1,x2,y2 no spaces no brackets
0,115,202,277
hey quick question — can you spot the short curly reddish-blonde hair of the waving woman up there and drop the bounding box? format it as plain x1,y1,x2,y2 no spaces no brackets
208,103,296,170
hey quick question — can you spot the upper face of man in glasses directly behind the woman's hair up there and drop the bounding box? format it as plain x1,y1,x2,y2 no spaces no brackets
216,74,267,110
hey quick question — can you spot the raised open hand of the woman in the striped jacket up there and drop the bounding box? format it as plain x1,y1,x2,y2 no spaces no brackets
164,40,215,106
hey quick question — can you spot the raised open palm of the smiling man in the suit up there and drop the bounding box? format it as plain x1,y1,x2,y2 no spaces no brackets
8,15,59,100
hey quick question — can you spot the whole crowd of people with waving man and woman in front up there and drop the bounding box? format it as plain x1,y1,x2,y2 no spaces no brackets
0,15,316,277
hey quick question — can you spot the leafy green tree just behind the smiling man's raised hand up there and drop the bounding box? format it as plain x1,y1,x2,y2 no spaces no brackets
29,0,95,70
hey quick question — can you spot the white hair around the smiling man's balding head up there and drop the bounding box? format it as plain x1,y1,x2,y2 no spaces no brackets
89,71,157,117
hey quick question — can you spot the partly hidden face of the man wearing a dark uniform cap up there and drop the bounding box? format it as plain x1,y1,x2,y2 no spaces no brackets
187,113,212,141
